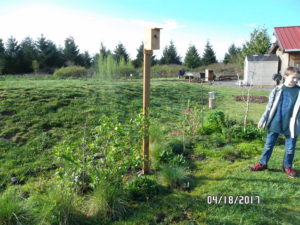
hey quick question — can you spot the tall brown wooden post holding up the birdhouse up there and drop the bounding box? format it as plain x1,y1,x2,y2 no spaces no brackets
142,49,153,174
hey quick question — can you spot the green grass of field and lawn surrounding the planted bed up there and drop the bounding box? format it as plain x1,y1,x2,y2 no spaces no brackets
0,76,300,225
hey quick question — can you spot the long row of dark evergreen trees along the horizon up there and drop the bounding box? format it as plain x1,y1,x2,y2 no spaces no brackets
0,28,271,74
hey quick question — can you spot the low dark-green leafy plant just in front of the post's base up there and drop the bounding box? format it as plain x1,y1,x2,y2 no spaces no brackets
127,176,161,201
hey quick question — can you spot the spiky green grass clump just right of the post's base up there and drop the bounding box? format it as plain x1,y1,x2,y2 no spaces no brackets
159,164,190,189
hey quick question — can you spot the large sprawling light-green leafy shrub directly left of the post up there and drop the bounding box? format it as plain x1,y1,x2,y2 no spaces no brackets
56,115,143,192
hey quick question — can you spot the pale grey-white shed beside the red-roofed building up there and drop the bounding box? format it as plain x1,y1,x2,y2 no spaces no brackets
243,54,279,85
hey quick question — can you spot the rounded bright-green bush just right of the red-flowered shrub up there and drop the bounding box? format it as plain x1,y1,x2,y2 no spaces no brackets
203,110,225,134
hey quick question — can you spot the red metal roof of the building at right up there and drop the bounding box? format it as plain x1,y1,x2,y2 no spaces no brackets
274,26,300,52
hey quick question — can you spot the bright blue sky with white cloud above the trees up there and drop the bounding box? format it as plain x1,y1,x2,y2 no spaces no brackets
0,0,300,60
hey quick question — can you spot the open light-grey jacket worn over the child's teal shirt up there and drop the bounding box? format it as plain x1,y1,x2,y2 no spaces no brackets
259,84,300,138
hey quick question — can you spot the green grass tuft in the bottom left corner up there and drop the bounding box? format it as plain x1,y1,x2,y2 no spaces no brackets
0,189,32,225
